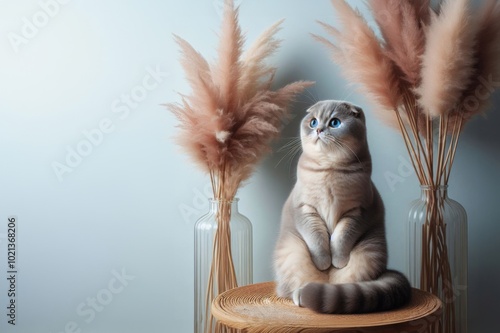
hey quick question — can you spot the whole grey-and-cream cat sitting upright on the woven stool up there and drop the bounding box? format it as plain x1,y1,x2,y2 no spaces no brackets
274,101,411,313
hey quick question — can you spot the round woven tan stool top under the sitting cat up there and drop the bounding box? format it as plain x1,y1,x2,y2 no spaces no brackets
212,282,441,333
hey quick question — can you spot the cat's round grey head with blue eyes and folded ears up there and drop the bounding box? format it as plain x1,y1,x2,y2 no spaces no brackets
300,100,367,162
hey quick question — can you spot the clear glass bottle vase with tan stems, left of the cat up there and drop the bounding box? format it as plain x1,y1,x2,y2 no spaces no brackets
194,199,253,333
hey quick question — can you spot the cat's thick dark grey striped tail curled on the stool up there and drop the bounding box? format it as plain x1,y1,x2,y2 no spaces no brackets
294,270,411,314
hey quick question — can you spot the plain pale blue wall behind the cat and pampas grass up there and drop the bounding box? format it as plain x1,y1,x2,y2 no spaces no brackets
0,0,500,333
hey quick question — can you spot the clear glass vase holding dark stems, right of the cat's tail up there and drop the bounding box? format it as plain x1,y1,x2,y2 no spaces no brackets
407,186,467,333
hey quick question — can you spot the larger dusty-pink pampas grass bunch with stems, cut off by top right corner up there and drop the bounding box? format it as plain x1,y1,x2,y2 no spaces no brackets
314,0,500,176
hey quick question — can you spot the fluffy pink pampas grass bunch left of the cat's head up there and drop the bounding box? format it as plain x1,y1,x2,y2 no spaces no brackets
166,0,312,195
